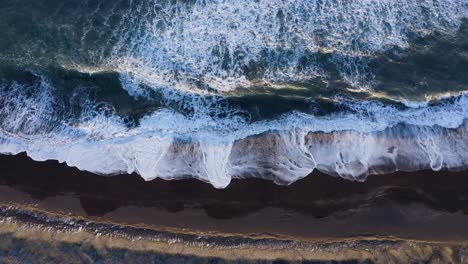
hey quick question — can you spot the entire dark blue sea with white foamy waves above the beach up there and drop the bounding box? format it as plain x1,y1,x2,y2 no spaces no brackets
0,0,468,188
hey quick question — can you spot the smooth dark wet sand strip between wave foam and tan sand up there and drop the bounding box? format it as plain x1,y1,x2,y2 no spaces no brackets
0,155,468,241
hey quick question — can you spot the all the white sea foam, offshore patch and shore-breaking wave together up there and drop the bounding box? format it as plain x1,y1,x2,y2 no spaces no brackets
0,0,468,188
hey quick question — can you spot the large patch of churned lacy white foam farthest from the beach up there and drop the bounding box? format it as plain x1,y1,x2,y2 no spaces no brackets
104,0,468,92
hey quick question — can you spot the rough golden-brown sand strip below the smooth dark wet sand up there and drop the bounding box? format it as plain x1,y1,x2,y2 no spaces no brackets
0,206,468,263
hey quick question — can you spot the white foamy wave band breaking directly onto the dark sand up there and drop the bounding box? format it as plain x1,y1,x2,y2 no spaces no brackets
0,72,468,188
